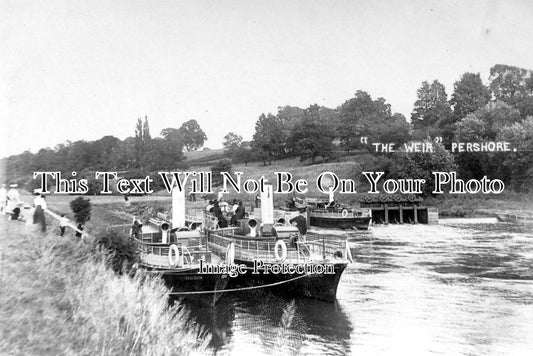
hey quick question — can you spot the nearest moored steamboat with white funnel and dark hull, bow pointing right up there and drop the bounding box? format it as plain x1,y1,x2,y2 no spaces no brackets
204,185,351,301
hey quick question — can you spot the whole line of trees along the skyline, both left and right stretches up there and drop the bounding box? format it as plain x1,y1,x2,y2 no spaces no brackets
0,64,533,191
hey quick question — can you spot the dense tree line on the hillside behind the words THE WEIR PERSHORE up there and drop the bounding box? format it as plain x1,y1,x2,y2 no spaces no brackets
223,64,533,191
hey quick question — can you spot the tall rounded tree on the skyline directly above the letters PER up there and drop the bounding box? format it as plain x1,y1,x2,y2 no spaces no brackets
450,73,490,122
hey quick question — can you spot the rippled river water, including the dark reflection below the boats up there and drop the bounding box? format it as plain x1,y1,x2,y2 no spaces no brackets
184,220,533,355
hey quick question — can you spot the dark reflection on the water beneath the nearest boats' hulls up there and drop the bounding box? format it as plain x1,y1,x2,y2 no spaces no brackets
181,291,353,355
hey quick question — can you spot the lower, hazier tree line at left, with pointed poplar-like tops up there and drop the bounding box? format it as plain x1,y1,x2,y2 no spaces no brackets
0,117,207,194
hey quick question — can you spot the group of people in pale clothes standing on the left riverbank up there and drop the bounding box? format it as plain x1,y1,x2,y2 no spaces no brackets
0,183,83,237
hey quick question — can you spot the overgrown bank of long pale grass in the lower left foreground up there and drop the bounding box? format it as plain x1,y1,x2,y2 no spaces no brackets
0,216,209,355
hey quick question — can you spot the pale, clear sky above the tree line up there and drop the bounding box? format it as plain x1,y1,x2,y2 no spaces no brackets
0,0,533,157
